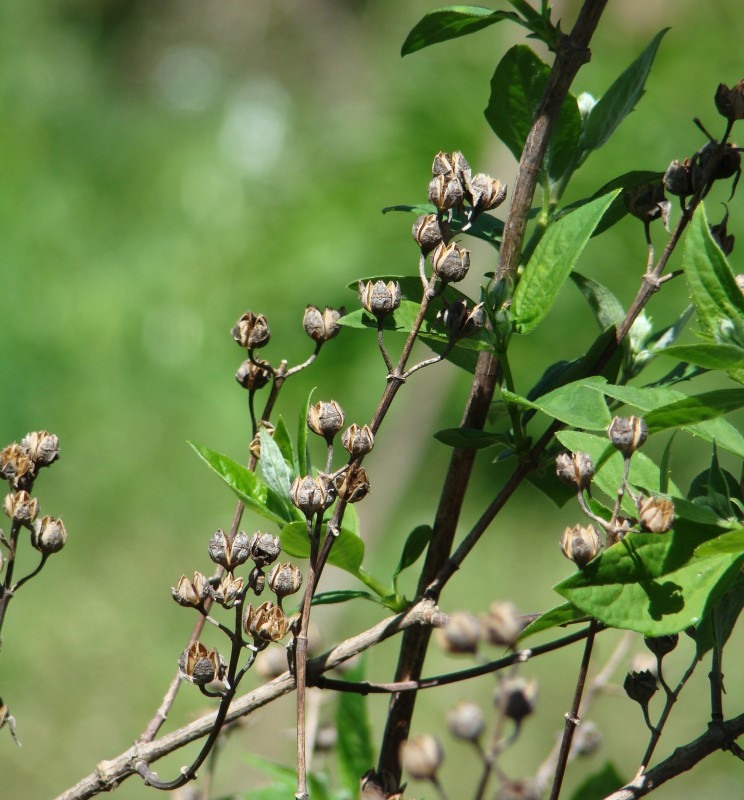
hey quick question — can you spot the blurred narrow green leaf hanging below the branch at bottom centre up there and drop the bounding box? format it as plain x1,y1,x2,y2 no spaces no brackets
336,662,375,797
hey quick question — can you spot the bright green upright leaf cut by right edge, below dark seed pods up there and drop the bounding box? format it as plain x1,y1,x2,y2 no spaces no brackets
682,204,744,346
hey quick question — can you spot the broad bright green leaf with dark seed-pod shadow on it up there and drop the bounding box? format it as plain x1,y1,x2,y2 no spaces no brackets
555,520,744,636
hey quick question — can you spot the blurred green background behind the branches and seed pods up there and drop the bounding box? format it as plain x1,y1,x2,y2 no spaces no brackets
0,0,744,800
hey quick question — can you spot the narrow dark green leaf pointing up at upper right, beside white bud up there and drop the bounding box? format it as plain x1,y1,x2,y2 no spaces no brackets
581,28,669,153
